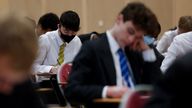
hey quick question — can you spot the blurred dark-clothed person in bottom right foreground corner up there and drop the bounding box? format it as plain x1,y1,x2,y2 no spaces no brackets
145,52,192,108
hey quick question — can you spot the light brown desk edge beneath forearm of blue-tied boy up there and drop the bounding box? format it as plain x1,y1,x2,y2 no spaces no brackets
94,98,121,103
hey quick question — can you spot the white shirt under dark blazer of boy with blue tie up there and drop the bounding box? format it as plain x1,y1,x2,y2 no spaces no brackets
102,31,156,98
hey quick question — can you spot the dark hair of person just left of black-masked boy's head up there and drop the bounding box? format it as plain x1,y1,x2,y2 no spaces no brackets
38,13,59,30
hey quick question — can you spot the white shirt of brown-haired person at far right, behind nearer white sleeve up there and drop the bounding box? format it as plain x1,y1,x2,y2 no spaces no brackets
156,29,178,56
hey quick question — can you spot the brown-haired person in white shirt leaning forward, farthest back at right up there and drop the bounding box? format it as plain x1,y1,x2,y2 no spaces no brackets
156,16,192,56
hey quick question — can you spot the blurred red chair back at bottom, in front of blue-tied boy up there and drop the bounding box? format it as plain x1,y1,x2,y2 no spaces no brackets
120,85,152,108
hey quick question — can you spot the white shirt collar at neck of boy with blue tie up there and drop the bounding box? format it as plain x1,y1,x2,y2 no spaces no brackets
106,30,120,54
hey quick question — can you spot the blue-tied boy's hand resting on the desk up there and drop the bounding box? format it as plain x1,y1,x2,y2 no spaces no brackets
107,86,129,98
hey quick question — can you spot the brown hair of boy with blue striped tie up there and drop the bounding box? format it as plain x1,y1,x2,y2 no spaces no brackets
120,2,159,34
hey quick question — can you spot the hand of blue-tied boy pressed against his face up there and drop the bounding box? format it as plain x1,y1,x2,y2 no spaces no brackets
131,37,150,52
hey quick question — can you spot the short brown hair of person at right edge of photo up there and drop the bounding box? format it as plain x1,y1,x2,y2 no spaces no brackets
178,16,192,32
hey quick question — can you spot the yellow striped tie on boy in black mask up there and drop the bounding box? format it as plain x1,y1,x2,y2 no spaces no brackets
57,43,65,65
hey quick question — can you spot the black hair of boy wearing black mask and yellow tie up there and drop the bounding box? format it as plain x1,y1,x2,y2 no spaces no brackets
60,11,80,31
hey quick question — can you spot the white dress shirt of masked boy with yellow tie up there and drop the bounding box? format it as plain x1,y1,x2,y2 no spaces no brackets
33,30,82,81
